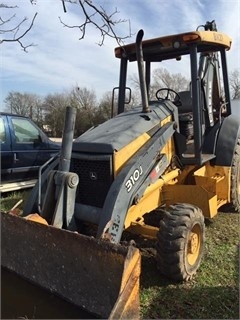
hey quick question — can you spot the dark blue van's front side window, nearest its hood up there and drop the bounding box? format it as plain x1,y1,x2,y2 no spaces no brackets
12,118,40,143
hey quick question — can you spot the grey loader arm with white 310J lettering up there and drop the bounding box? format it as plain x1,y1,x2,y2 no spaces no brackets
97,122,176,243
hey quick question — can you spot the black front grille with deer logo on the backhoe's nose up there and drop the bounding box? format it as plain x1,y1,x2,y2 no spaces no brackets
70,158,113,208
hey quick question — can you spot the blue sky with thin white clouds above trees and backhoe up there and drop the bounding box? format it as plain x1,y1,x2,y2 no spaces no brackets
0,0,240,110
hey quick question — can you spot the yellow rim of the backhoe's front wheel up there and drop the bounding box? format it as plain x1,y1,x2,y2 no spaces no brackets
187,225,202,265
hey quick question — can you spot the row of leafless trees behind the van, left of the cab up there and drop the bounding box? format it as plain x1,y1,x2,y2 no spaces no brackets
4,87,105,137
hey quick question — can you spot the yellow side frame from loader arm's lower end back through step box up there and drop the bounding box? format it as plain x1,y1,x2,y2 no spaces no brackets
125,160,231,228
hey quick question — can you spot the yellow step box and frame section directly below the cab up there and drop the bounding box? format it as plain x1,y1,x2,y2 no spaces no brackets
162,163,231,218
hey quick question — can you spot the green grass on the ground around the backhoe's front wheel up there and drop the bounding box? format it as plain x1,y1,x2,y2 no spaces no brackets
0,192,239,319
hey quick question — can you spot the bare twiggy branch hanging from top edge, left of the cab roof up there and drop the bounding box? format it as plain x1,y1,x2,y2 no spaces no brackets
59,0,131,46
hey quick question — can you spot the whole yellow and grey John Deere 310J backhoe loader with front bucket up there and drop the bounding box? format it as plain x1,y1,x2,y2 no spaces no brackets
2,21,240,319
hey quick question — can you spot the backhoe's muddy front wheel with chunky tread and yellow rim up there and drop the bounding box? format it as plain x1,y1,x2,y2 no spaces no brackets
157,203,205,281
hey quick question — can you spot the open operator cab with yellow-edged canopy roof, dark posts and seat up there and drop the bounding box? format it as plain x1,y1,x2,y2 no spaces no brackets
115,21,231,165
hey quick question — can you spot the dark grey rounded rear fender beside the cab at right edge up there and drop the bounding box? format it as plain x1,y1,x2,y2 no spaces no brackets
215,114,240,167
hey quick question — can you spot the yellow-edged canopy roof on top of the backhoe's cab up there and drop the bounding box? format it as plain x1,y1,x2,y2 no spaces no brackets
115,30,232,61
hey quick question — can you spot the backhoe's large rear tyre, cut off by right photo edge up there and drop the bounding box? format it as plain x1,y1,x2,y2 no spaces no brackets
231,137,240,213
